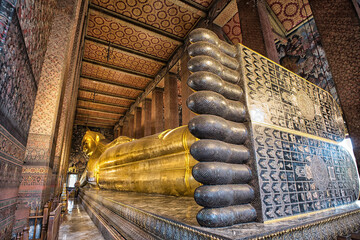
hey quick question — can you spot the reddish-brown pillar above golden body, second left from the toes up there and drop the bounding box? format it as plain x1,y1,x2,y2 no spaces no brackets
164,73,179,129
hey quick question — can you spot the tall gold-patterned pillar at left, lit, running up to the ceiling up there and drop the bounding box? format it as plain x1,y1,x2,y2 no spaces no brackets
17,0,80,227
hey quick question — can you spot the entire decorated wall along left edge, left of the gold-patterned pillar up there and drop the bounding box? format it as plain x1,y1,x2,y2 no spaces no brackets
0,0,54,239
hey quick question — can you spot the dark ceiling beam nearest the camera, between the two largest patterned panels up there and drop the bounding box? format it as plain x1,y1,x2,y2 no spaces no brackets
90,3,182,42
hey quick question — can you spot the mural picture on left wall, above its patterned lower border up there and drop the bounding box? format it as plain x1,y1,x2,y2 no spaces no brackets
0,17,37,145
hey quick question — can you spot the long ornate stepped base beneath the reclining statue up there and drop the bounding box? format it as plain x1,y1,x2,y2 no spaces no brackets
80,188,360,240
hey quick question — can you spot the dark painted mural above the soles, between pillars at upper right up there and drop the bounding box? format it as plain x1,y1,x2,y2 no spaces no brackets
276,19,339,103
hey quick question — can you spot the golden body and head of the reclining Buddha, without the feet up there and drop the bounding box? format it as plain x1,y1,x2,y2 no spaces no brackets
81,126,200,196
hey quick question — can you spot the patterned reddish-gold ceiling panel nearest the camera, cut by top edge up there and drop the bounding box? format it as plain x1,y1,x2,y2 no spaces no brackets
91,0,202,37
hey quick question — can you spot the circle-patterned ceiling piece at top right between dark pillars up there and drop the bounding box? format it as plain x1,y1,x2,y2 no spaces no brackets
267,0,312,31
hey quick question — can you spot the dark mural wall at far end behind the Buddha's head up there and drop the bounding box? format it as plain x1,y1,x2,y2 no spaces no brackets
69,125,114,172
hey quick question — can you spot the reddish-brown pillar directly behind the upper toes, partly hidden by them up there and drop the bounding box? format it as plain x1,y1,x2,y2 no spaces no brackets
180,54,195,125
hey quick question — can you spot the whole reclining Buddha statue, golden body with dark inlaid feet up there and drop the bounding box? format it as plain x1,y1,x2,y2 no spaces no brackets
83,28,360,227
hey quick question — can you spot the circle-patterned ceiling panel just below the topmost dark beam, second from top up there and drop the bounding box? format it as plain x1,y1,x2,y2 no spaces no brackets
87,10,181,59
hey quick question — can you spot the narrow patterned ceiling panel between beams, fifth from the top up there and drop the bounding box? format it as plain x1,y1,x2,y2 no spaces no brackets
80,78,142,99
